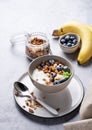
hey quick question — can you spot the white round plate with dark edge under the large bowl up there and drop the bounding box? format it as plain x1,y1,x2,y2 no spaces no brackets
14,73,84,118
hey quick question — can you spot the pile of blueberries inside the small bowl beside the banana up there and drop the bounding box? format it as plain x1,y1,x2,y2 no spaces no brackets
60,34,78,47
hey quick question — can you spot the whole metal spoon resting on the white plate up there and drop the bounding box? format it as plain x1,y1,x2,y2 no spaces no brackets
14,82,59,115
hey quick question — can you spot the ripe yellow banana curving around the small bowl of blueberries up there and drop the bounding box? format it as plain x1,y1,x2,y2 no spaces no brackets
58,22,92,64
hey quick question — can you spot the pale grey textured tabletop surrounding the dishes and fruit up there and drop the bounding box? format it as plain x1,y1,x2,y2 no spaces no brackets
0,0,92,130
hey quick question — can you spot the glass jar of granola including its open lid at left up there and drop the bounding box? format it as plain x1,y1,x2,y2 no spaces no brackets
10,32,51,60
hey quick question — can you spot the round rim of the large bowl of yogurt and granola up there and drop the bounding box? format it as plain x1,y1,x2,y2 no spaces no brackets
28,55,74,87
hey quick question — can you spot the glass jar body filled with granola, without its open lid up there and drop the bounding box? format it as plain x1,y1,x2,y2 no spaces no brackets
25,32,50,59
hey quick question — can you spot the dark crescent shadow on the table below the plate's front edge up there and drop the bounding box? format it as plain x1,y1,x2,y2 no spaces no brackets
16,103,80,125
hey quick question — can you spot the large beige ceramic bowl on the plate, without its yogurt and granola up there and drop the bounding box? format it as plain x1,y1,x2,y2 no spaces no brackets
28,55,74,93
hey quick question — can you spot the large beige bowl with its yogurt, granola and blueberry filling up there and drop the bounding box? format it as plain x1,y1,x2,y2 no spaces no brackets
28,55,74,93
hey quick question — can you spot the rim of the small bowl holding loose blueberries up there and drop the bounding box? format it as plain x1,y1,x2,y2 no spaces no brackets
59,32,80,49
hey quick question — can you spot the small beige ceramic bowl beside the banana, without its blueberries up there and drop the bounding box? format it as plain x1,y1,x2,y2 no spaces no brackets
59,33,80,53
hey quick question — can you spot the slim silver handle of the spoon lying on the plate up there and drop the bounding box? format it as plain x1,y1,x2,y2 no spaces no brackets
35,99,59,115
